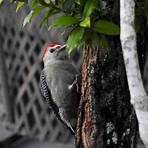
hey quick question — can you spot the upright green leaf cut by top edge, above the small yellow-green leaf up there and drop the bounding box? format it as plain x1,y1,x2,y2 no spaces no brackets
83,0,97,17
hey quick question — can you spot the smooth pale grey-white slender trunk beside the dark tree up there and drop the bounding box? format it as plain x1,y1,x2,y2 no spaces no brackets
120,0,148,147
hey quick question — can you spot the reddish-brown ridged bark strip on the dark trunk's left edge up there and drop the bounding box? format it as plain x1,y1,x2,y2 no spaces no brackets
76,47,98,148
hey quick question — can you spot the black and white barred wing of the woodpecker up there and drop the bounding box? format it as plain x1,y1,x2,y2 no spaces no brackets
40,71,74,134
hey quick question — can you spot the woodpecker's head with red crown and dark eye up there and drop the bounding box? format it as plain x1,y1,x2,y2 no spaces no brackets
43,43,68,63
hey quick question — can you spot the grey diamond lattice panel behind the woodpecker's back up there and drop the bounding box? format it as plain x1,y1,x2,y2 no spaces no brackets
0,24,71,142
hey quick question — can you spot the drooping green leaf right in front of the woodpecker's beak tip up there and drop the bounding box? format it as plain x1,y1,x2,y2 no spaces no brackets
67,27,85,54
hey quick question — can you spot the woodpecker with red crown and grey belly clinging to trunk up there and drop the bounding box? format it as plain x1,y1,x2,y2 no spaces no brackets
40,44,80,134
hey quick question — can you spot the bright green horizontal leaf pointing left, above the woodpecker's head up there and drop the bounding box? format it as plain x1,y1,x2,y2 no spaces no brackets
49,16,79,28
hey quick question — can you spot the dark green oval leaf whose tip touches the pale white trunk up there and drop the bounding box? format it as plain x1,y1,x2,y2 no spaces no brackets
93,20,120,35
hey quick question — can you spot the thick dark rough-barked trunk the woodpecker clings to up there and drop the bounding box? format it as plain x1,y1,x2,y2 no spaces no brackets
76,41,138,148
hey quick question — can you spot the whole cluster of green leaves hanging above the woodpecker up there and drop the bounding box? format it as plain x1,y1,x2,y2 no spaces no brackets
5,0,120,53
